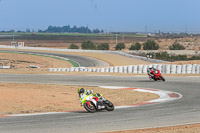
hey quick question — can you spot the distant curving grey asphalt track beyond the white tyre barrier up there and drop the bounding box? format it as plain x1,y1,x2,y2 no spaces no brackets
0,50,109,67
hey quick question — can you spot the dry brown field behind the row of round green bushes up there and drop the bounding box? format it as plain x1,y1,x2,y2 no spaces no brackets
0,35,200,50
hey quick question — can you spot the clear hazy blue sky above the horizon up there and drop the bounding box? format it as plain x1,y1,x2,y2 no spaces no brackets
0,0,200,33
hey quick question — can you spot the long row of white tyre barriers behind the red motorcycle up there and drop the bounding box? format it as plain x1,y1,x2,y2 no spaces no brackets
48,64,200,74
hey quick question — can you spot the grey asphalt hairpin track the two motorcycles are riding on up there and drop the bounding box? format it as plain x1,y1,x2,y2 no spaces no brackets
0,74,200,133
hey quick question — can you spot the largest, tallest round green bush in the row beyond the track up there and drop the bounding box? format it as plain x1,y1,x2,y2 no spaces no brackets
143,40,159,50
